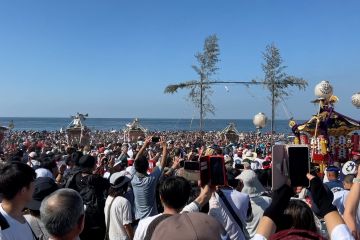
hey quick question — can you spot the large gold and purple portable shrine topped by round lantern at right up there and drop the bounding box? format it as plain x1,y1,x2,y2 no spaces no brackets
289,81,360,170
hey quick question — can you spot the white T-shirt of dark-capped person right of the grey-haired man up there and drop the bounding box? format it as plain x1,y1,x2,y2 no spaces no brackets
104,196,132,240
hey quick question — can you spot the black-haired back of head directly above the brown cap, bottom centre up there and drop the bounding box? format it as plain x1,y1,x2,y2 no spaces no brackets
159,176,191,210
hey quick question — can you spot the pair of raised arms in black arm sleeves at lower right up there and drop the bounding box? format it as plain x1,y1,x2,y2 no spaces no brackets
253,174,354,240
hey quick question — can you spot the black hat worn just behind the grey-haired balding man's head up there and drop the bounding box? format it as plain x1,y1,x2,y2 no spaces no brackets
26,177,58,210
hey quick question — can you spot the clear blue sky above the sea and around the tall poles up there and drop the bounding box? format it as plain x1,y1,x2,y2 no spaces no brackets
0,0,360,119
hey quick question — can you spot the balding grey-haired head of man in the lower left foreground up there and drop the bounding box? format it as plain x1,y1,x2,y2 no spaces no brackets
40,188,84,237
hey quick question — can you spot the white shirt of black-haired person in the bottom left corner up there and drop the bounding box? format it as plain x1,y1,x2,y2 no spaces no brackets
0,204,34,240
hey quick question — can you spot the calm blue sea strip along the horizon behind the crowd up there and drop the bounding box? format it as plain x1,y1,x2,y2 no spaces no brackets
0,117,303,133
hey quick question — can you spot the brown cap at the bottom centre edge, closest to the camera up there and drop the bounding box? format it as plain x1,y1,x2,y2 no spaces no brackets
151,212,227,240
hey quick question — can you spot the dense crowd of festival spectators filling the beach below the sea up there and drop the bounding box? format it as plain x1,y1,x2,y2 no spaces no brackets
0,131,360,240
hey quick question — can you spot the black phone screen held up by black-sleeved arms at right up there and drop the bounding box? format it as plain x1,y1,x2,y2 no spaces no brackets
287,146,310,187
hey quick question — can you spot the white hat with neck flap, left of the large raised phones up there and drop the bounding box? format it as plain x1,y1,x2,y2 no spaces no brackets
236,170,265,197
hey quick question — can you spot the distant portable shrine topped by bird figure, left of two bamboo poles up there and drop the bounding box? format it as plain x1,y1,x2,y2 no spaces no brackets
66,113,90,146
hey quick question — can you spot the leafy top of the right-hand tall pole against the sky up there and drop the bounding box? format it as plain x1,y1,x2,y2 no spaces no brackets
262,43,308,103
